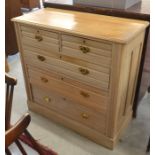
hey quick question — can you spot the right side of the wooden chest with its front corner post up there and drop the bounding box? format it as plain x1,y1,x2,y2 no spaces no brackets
107,32,145,137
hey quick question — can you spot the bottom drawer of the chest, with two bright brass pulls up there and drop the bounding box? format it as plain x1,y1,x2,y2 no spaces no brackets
32,85,105,133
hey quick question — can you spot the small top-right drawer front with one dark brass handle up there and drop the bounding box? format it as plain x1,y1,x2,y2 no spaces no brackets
61,35,112,68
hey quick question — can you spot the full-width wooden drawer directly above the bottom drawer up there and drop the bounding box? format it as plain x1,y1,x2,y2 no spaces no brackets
28,67,108,112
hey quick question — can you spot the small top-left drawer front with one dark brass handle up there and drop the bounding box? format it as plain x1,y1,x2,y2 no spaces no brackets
21,26,59,52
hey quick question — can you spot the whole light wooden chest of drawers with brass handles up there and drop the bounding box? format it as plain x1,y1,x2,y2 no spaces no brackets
13,8,148,148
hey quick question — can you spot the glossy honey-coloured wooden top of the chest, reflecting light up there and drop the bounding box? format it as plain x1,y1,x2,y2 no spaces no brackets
12,8,149,43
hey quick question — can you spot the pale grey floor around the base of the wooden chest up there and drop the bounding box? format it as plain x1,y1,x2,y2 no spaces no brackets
8,54,150,155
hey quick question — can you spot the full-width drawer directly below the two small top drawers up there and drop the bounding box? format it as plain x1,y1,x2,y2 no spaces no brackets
24,51,109,90
